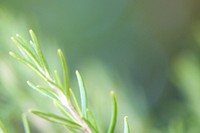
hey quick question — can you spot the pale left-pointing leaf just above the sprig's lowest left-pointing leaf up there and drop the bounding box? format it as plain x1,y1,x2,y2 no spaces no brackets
27,81,59,100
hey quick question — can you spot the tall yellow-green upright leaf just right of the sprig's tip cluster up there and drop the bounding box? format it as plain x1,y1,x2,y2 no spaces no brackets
58,49,69,95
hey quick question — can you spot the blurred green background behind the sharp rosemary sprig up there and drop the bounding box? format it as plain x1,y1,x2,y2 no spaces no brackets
0,0,200,133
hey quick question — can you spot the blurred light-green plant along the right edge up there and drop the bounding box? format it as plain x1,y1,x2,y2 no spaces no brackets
173,25,200,133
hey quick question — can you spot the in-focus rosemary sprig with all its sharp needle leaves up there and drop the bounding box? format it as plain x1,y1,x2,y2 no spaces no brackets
0,30,130,133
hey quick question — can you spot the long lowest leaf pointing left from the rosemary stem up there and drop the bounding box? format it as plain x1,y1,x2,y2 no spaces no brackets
30,110,81,129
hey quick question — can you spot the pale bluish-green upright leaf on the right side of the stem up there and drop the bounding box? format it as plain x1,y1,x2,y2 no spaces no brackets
76,71,87,118
